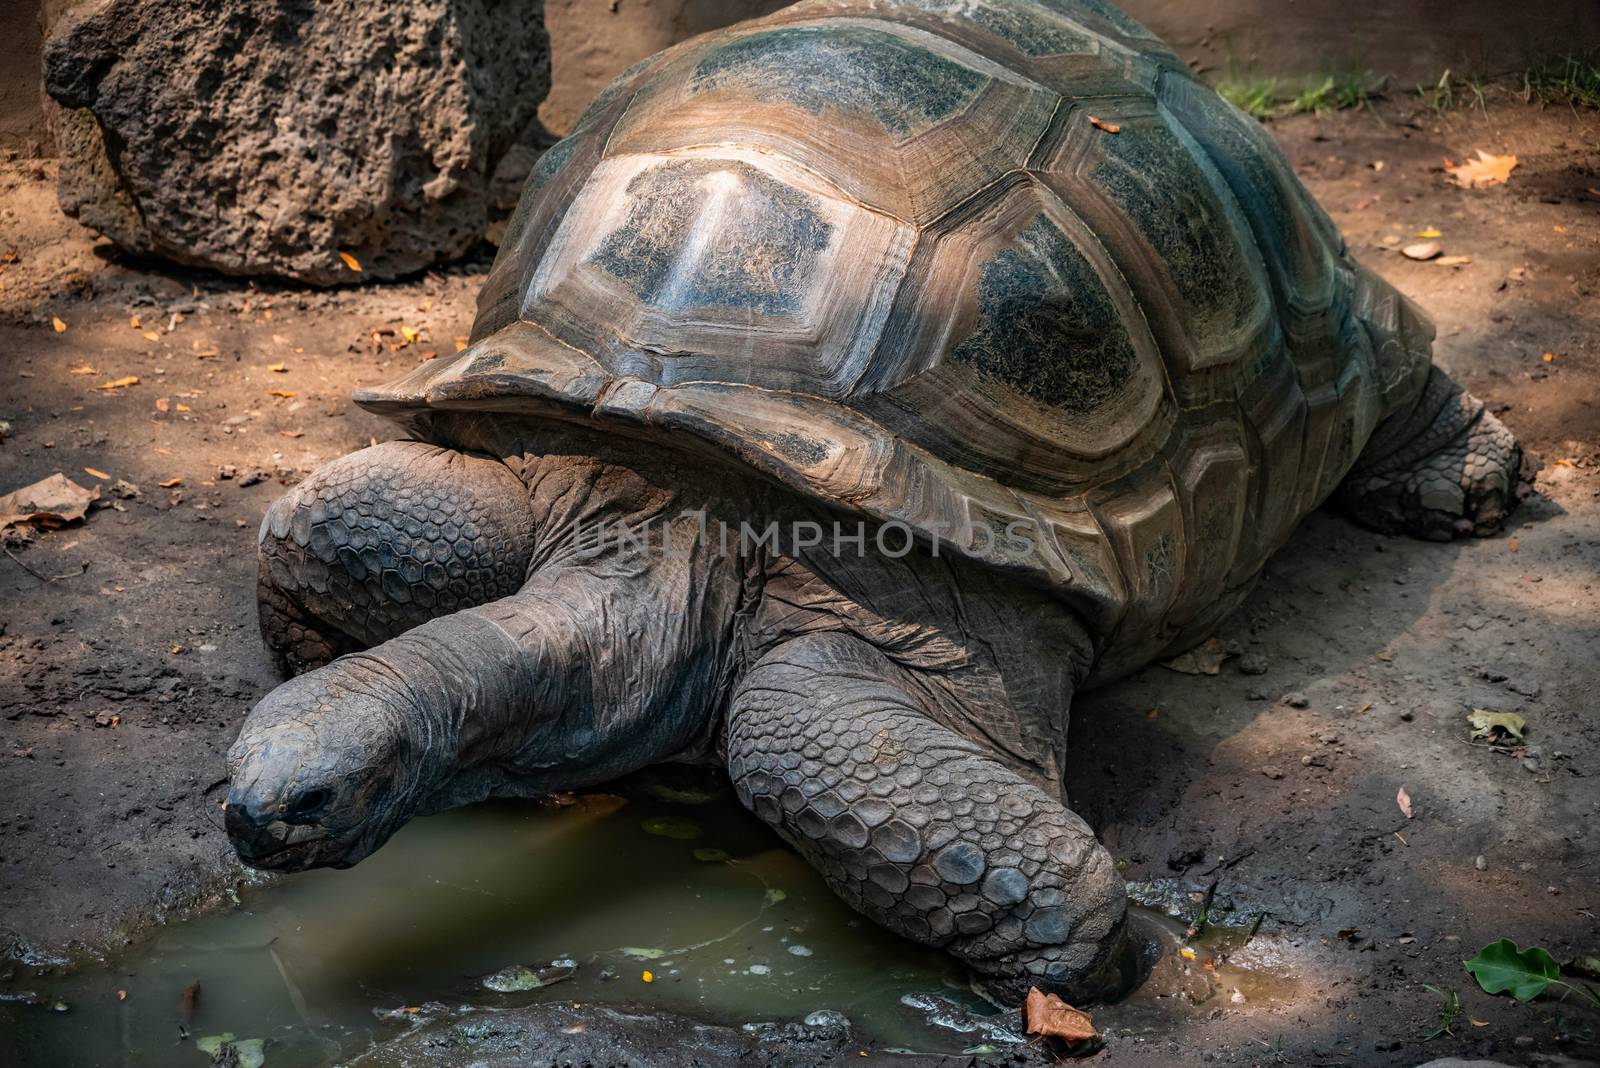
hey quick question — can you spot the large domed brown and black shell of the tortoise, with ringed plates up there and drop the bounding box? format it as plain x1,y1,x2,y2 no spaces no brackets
357,0,1432,665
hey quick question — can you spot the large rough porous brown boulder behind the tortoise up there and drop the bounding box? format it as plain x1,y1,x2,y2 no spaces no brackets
45,0,549,285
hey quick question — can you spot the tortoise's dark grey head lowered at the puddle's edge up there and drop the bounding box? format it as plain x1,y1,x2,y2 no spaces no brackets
226,668,430,871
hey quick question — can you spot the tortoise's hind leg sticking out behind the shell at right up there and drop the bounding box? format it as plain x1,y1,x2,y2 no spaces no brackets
1336,368,1523,542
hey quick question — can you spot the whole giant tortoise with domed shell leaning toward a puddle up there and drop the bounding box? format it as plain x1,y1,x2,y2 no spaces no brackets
227,0,1520,999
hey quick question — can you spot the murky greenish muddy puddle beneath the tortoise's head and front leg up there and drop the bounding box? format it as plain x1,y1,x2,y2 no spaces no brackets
0,780,1293,1068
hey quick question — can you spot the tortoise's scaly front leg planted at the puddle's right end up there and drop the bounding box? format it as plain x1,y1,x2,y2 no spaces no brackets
728,633,1126,1004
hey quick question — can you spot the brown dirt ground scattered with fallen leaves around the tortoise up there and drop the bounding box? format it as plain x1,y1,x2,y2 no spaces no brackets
0,98,1600,1065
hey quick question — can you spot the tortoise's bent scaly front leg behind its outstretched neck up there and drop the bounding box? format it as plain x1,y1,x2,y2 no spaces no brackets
258,441,533,673
